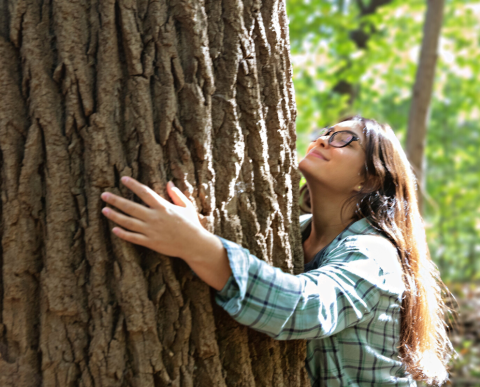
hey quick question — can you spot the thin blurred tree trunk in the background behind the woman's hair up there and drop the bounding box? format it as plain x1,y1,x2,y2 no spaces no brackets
407,0,445,211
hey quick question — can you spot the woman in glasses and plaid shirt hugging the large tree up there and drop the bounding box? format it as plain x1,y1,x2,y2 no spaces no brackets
102,116,451,386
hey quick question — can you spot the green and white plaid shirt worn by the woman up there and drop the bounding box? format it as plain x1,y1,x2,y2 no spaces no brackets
215,215,416,387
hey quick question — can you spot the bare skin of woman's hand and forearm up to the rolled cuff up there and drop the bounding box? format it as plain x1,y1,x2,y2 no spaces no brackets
101,177,231,290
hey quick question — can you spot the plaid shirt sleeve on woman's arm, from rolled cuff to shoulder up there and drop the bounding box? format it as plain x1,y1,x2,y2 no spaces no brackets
215,237,401,340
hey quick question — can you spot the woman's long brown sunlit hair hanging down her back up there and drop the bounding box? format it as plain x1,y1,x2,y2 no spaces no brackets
300,116,453,385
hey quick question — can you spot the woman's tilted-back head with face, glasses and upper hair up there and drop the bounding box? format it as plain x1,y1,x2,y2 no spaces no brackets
299,116,415,219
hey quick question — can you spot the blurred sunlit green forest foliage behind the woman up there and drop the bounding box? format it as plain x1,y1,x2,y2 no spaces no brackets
287,0,480,385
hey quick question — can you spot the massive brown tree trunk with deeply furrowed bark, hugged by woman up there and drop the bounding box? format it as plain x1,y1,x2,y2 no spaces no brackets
0,0,309,387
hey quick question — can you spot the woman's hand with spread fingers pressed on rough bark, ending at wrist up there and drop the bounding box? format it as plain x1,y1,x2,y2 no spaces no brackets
101,177,205,259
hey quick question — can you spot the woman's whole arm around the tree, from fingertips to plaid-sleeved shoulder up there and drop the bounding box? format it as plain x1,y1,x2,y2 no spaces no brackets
102,178,401,340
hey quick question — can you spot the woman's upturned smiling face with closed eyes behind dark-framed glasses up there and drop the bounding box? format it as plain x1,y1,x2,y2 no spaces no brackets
299,121,365,195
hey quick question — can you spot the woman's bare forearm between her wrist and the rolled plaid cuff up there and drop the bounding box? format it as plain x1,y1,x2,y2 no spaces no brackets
181,230,232,290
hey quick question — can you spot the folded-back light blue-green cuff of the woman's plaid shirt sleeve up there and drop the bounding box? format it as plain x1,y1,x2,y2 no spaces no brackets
215,235,250,316
